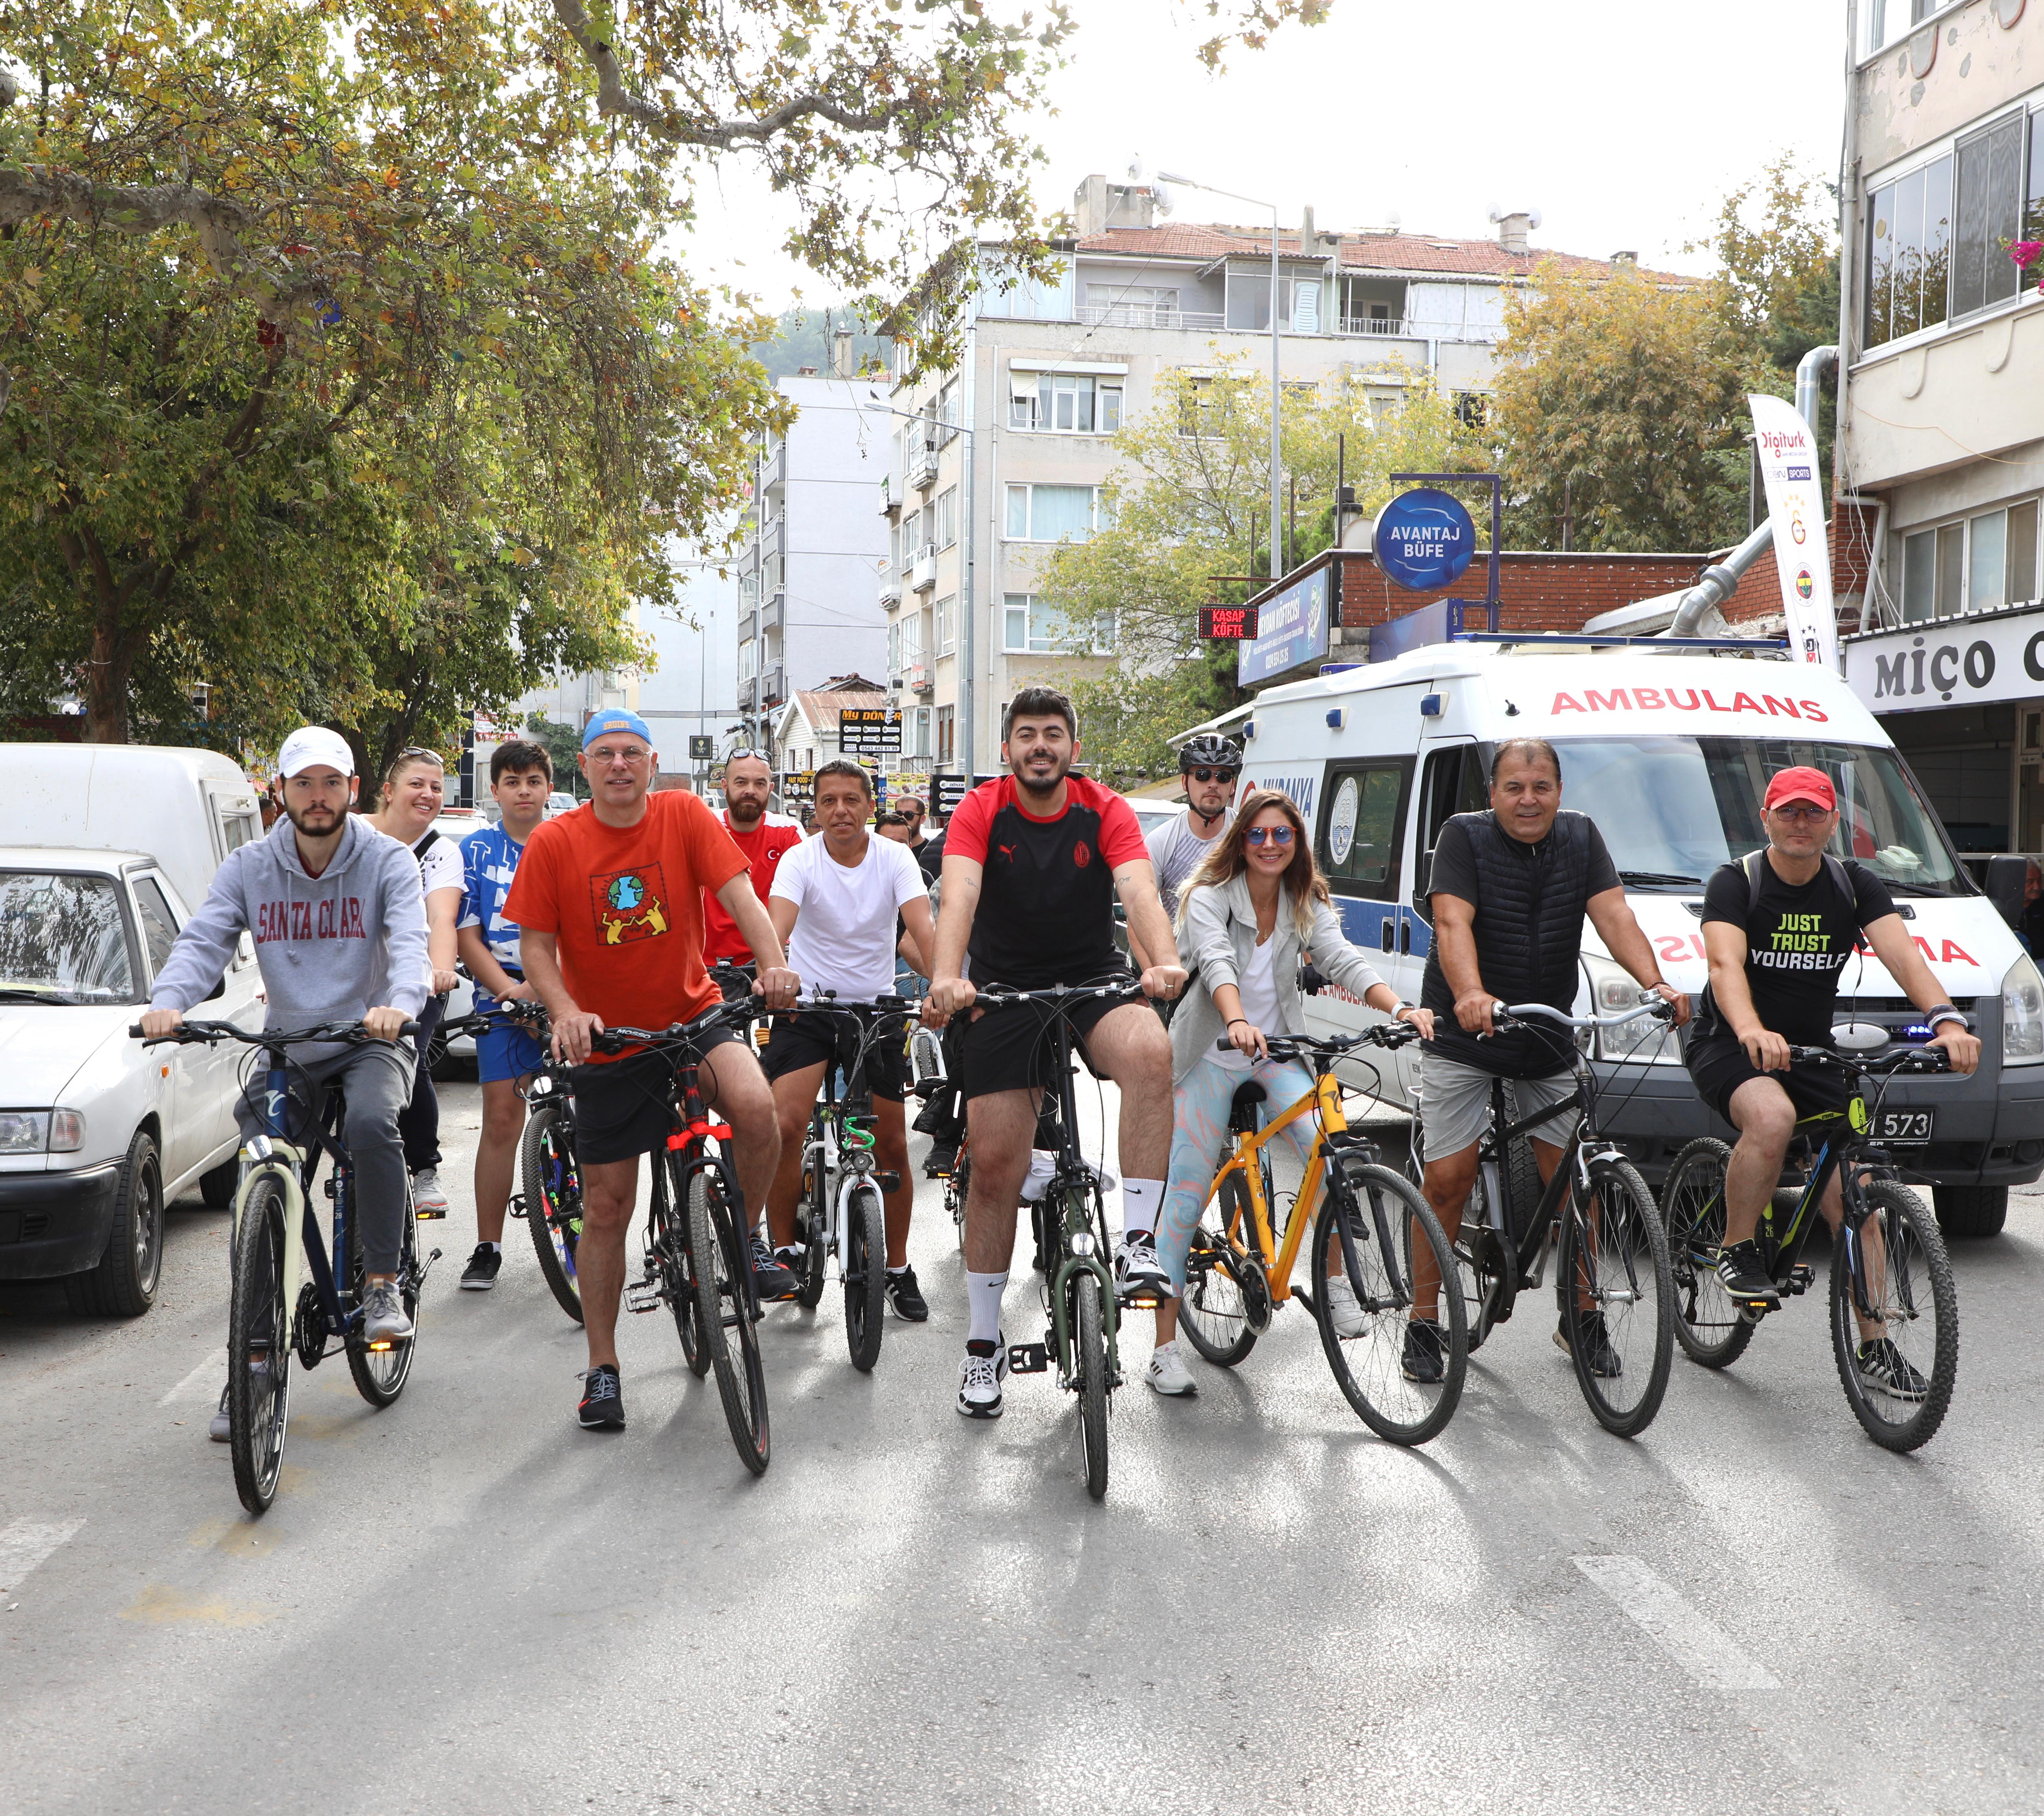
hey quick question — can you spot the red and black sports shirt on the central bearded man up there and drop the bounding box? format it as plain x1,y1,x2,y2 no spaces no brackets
944,776,1149,991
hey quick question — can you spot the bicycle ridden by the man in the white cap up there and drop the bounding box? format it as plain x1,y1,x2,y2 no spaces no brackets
129,1022,439,1514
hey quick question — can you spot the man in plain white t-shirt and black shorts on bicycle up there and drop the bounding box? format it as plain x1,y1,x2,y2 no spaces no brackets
761,758,934,1324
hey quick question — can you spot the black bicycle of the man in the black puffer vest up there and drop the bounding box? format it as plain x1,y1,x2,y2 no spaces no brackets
1414,1001,1676,1438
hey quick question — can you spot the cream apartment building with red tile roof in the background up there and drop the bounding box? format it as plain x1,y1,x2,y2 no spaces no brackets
879,176,1660,774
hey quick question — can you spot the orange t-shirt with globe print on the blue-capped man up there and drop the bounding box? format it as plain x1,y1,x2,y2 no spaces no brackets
503,788,748,1060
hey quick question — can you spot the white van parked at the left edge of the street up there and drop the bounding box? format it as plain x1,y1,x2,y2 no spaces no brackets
0,743,264,1315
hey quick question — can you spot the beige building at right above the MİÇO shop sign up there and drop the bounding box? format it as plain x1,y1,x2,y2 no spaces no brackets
1838,0,2044,852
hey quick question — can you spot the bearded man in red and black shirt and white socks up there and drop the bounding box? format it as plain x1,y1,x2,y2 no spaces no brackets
924,686,1185,1420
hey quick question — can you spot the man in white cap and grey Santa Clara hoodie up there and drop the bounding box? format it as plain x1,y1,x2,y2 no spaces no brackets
141,725,429,1442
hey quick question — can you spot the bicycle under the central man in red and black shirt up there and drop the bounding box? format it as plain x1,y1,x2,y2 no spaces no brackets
977,981,1142,1501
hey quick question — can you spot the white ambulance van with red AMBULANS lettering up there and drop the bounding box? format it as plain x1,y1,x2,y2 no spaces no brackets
1198,635,2044,1234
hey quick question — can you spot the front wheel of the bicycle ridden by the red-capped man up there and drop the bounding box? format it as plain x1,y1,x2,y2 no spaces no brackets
1832,1179,1958,1450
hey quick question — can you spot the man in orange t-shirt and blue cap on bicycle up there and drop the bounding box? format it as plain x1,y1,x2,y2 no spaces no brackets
503,711,797,1430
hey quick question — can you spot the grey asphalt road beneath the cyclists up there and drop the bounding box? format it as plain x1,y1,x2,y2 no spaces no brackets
0,1087,2044,1816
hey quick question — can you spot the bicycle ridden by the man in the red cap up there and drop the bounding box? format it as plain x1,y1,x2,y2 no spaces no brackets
1662,1030,1958,1450
